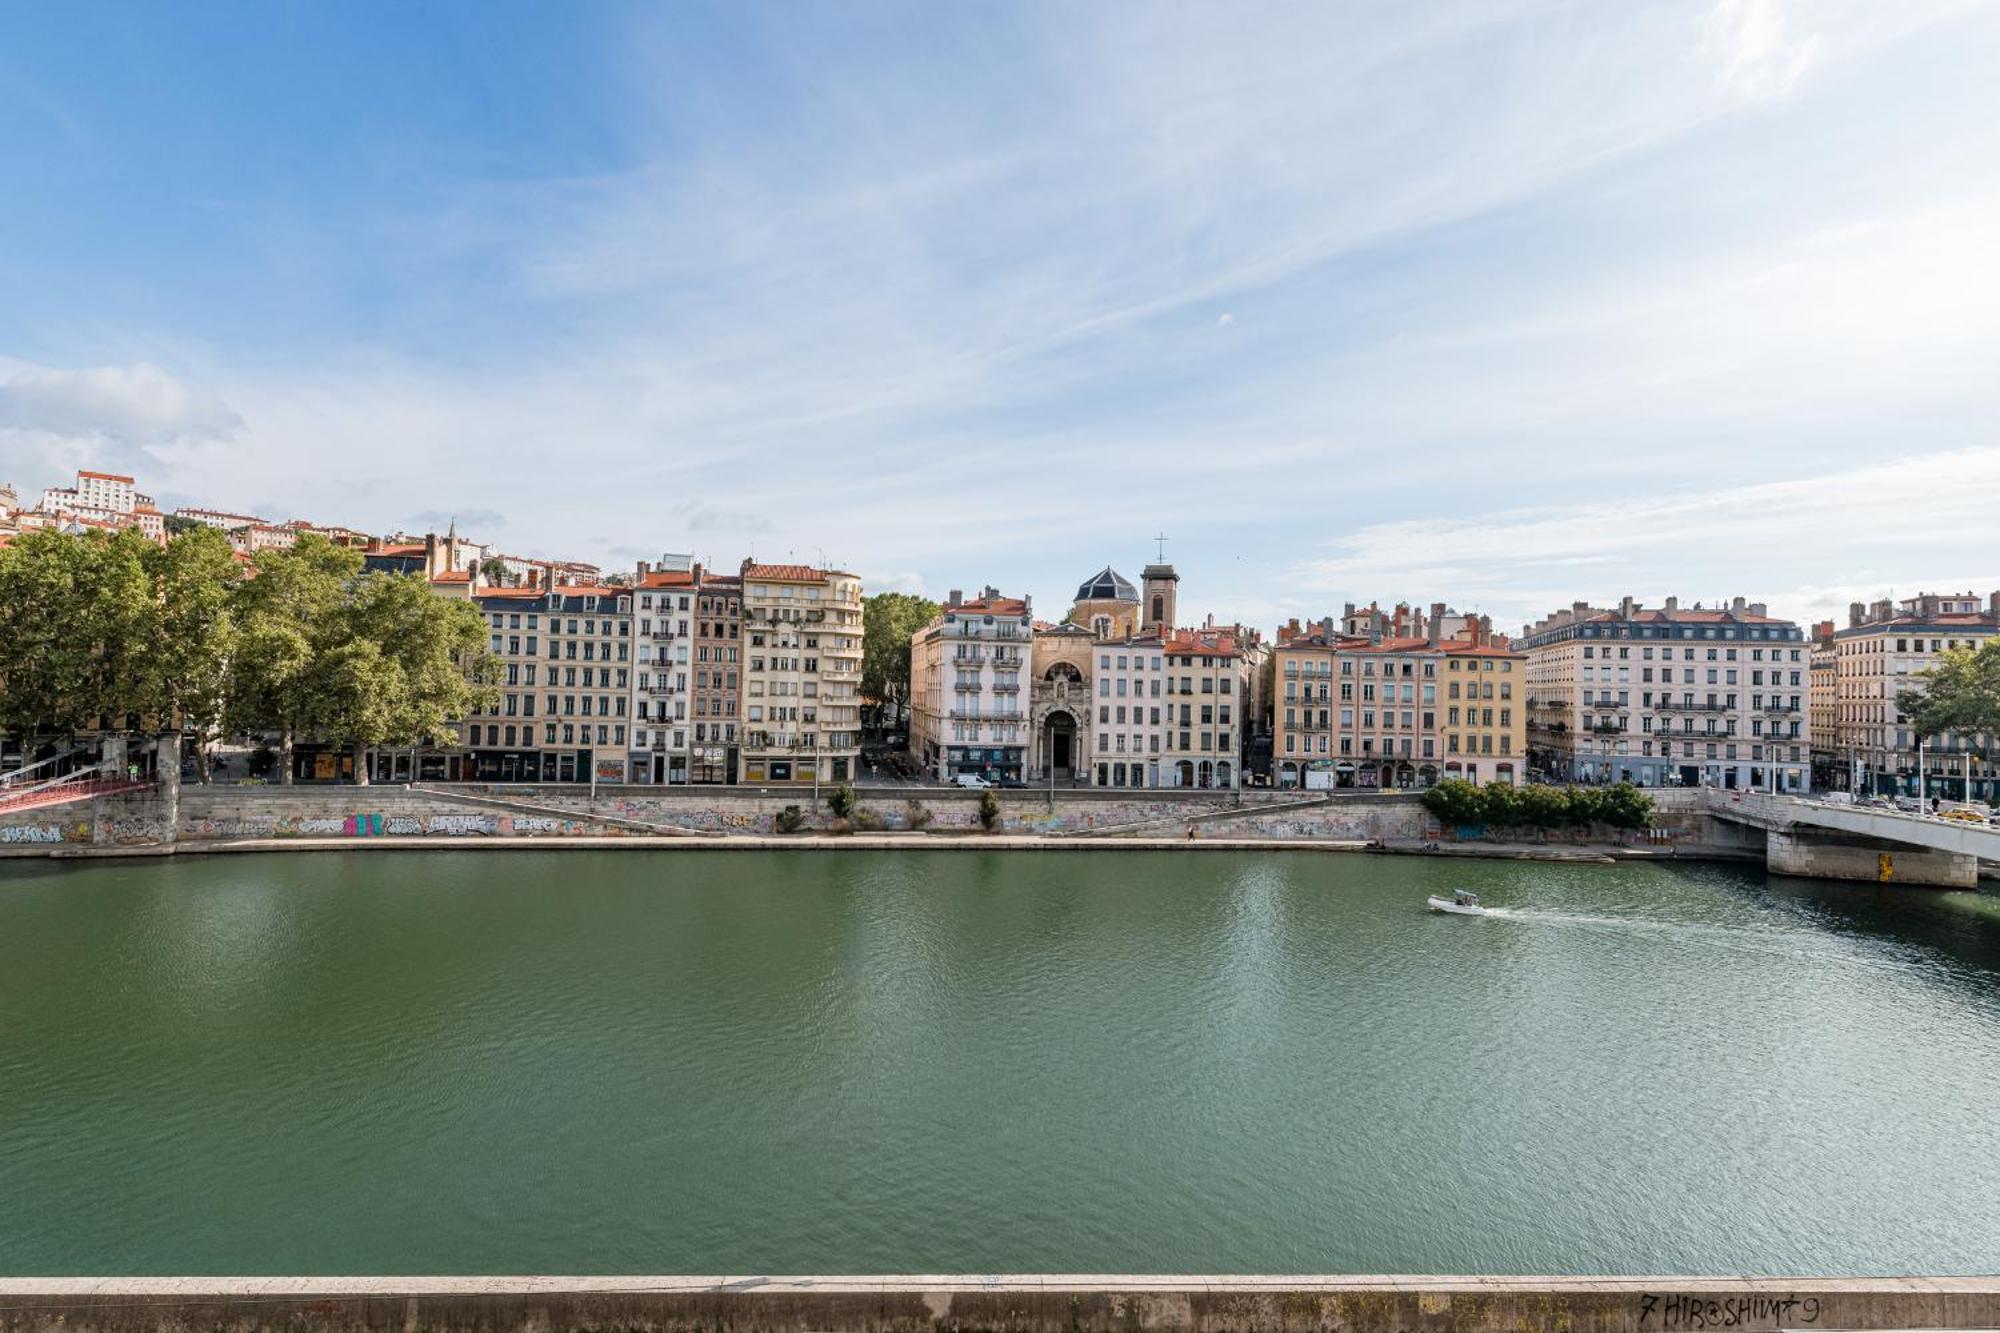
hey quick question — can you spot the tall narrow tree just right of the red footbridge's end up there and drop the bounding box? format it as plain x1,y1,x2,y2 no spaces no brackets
146,524,242,783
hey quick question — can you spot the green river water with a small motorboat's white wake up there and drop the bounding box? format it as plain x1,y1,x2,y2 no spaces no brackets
0,851,2000,1275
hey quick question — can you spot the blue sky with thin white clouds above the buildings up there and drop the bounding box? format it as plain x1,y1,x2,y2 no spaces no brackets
0,0,2000,626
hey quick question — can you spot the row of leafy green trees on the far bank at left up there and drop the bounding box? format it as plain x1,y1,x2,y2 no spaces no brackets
0,526,496,773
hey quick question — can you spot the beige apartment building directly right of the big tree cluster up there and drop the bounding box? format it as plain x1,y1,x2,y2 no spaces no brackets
460,584,632,783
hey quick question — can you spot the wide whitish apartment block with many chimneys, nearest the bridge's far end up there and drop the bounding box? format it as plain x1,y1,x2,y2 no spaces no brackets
1514,596,1812,791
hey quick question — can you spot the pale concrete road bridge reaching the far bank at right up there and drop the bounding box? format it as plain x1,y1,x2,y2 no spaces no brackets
1708,789,2000,889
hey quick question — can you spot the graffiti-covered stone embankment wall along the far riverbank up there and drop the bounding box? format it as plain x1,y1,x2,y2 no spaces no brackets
0,785,1760,857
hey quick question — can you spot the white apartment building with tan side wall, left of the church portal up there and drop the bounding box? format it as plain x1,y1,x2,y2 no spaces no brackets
910,588,1034,783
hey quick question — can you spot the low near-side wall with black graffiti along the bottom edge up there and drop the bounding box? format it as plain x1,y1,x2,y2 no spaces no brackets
0,1275,2000,1333
